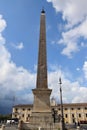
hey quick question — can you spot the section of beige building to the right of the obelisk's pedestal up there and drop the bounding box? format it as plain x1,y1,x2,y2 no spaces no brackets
55,103,87,124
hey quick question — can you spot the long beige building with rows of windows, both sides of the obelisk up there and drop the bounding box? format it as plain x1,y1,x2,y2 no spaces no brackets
12,101,87,124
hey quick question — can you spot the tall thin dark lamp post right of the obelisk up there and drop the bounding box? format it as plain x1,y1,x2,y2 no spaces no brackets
59,78,65,130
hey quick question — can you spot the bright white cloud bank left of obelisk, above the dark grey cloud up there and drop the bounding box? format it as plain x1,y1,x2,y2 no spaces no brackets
0,45,36,91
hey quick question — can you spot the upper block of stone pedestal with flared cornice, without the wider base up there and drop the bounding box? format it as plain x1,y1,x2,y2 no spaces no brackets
32,89,52,113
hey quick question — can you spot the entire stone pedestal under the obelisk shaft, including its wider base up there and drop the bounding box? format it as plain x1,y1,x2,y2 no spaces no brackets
30,89,53,127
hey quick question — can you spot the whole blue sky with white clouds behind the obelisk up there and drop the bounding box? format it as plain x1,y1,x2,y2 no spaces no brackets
0,0,87,113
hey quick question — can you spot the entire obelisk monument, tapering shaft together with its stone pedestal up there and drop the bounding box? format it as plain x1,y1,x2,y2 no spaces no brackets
32,10,52,124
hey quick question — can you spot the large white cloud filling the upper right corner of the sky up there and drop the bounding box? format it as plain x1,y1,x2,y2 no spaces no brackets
47,0,87,58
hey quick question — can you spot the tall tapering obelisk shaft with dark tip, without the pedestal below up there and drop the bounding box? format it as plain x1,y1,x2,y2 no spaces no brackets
36,10,48,89
